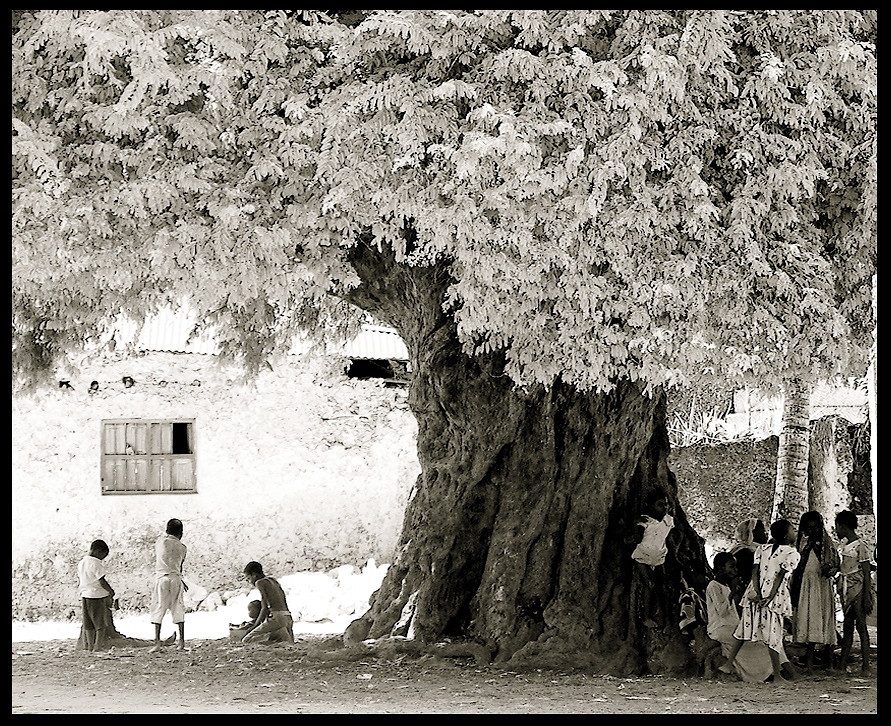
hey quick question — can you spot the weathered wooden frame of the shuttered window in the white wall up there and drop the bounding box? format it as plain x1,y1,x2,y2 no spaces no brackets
99,418,198,496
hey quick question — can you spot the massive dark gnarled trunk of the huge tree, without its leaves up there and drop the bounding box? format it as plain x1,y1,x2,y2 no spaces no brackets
346,248,707,674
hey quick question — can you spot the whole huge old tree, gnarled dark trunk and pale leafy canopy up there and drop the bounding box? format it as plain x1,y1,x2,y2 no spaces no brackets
12,10,877,673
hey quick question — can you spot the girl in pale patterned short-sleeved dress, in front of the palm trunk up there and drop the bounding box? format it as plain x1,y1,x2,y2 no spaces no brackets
727,519,801,684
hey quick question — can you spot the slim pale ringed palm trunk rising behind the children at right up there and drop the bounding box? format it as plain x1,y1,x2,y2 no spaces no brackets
771,378,811,526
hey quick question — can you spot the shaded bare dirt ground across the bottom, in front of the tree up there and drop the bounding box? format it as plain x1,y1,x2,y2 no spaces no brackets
12,636,878,715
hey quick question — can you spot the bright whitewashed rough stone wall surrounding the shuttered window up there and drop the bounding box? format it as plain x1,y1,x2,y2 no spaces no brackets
12,353,420,619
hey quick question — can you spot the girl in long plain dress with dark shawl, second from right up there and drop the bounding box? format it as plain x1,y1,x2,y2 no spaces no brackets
791,511,839,671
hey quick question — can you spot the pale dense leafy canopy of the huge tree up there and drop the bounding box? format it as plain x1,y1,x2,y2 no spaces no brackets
12,10,877,390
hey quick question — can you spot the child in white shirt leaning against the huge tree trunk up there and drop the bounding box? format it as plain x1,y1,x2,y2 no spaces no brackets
631,489,674,628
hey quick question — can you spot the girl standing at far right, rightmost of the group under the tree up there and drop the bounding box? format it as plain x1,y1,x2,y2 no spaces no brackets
835,509,875,673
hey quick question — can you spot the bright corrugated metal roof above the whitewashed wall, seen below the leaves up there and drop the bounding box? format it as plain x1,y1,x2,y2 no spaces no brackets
136,309,408,360
